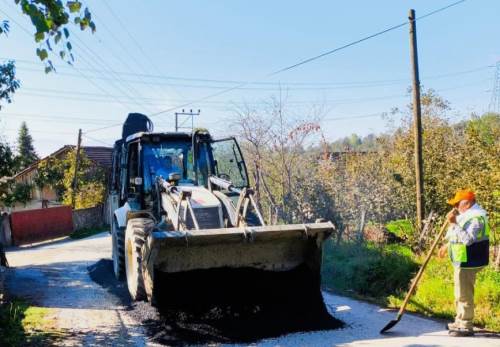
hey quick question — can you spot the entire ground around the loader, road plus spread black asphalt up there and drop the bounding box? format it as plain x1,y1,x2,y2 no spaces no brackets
6,233,500,347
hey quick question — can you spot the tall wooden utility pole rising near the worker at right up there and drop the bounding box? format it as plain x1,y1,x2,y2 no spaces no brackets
408,9,424,231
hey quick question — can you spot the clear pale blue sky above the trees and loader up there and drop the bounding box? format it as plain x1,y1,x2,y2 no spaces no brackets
0,0,500,156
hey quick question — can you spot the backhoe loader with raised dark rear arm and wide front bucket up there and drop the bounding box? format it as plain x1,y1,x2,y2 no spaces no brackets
109,114,333,310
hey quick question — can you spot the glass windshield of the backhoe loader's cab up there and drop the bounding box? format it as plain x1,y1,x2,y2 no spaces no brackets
142,141,208,192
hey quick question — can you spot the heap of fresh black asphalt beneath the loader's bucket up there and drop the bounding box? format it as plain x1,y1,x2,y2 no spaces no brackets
89,259,343,346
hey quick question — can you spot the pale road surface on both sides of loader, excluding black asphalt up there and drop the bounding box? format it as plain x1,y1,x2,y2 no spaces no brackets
6,233,500,347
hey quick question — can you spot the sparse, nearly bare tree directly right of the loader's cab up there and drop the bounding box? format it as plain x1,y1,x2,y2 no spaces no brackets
232,98,327,223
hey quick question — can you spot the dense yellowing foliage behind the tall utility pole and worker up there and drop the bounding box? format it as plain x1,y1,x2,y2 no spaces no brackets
321,90,500,250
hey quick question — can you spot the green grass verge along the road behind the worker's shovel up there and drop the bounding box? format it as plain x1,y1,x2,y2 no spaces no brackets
323,241,500,332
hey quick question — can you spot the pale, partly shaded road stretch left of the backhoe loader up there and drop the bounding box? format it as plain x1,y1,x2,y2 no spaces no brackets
6,233,146,346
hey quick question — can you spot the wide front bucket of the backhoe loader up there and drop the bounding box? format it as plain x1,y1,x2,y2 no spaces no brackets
144,222,333,316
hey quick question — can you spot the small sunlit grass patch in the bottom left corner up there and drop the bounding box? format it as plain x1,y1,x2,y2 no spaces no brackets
0,298,58,347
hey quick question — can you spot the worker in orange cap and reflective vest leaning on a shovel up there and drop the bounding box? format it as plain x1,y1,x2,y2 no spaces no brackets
439,189,489,336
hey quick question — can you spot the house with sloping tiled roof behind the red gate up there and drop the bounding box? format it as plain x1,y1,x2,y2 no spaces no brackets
12,145,113,210
